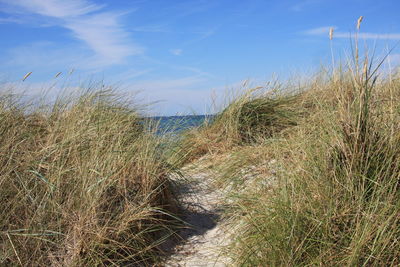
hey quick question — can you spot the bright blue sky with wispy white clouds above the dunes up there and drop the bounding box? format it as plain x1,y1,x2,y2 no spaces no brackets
0,0,400,115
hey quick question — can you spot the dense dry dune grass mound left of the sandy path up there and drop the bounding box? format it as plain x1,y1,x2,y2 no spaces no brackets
0,87,176,266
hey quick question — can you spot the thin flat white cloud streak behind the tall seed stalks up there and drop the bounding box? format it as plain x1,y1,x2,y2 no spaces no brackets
302,26,400,40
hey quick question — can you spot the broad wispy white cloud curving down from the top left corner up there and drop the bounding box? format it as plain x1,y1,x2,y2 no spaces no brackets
0,0,143,66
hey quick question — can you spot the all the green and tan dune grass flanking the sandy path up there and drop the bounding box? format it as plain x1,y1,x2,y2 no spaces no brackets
0,17,400,266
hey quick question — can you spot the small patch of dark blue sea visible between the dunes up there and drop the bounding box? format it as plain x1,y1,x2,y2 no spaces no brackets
149,115,213,135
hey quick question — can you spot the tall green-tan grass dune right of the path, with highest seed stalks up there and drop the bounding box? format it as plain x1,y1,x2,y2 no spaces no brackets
180,37,400,266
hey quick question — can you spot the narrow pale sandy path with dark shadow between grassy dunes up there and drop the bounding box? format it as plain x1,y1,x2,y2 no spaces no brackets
165,164,229,267
